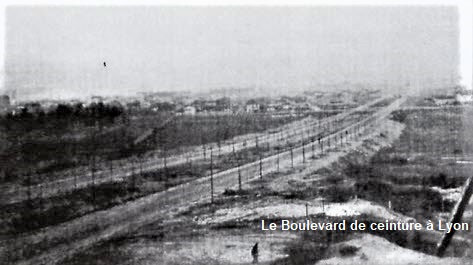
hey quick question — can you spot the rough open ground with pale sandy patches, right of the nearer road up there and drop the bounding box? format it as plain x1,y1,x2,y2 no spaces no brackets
58,100,473,265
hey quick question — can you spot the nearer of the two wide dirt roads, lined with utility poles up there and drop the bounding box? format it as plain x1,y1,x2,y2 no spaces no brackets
0,96,403,265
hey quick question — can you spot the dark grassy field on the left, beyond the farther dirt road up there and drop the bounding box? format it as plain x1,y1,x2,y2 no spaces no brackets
0,114,310,185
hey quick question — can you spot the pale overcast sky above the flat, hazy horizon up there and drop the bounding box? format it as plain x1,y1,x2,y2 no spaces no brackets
5,7,459,99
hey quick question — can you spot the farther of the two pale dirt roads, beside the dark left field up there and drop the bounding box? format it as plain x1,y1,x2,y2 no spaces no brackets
0,97,386,204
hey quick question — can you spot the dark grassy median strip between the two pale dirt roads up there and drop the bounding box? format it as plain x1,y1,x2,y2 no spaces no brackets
0,98,390,237
